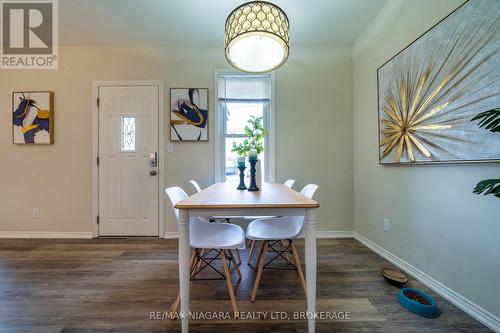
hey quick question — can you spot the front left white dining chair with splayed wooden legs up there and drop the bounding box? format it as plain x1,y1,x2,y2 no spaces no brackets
165,187,245,313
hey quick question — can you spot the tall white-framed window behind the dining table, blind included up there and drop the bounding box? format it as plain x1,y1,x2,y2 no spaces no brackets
216,72,274,181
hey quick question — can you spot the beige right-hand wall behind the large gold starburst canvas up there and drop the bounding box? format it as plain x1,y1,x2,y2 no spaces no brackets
353,0,500,316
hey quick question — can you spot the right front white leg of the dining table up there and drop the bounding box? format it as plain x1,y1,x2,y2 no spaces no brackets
305,208,317,333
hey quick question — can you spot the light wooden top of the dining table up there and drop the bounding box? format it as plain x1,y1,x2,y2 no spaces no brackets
175,183,319,209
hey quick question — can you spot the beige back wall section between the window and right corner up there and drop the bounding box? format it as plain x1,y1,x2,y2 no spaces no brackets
276,48,353,231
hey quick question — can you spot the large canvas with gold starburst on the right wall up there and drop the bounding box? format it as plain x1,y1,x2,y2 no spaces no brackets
377,0,500,164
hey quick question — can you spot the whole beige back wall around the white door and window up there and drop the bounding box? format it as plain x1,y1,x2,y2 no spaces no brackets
0,47,352,233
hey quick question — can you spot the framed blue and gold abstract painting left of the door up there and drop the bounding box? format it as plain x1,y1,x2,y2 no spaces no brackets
12,91,54,144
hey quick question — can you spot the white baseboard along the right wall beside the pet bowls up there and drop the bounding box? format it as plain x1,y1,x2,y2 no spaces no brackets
353,232,500,332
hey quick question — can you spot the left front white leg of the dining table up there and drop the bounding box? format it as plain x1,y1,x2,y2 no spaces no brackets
179,209,190,333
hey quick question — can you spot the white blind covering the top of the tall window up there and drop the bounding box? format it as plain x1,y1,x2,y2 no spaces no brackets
218,74,271,100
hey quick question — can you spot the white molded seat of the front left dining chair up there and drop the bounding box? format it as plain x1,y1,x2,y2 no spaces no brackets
189,218,245,249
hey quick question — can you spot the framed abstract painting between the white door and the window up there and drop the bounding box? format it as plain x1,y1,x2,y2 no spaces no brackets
170,88,208,141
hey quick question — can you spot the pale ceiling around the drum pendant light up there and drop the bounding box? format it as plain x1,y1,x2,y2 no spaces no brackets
59,0,387,46
